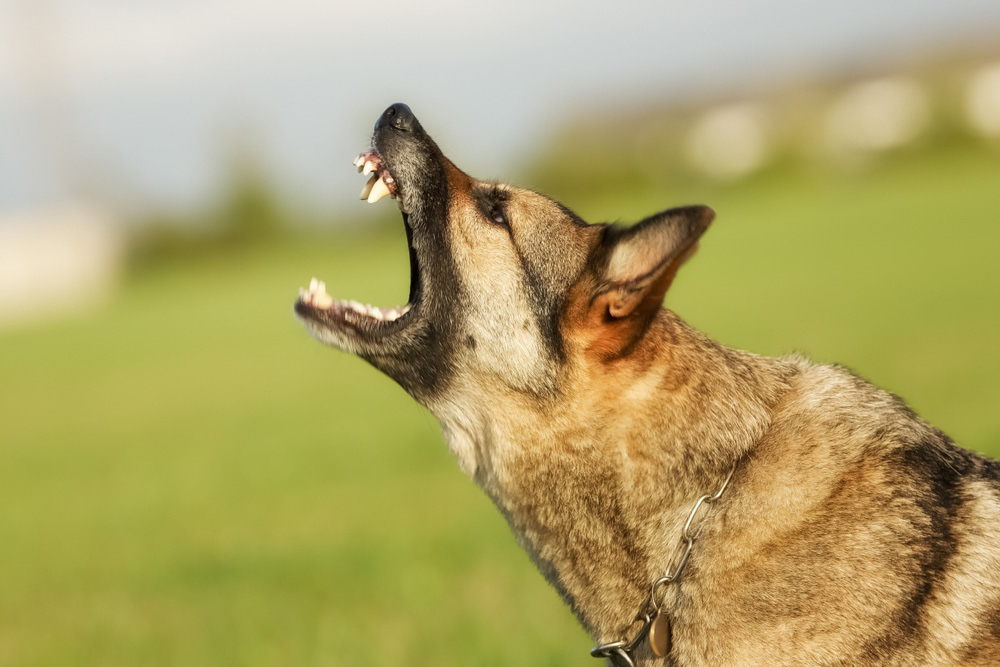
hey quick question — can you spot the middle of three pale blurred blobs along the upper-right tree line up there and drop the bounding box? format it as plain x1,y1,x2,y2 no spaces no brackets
825,77,931,154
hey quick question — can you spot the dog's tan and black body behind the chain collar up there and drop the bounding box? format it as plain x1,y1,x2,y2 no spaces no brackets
692,360,1000,666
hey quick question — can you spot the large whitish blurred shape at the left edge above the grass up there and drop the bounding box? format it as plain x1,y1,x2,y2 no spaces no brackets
0,203,124,327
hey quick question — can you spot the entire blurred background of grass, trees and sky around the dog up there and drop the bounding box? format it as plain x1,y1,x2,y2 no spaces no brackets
0,0,1000,667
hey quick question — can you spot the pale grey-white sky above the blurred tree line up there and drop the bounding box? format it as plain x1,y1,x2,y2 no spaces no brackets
0,0,1000,212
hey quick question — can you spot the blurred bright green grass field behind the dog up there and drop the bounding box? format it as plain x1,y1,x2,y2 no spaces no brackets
0,150,1000,667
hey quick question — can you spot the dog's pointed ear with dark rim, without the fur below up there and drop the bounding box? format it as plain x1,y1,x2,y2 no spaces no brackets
591,206,715,328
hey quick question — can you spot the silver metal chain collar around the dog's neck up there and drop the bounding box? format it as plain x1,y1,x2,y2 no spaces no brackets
590,467,736,667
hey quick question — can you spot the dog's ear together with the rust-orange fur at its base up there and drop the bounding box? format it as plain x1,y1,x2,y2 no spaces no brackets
577,206,715,357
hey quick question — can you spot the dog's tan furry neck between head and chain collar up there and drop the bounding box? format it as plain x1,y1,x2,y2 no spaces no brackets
432,310,793,639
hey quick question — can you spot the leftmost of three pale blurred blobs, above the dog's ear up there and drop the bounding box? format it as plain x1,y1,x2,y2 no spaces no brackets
687,103,768,178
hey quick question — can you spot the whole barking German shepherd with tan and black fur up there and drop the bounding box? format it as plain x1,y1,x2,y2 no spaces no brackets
295,104,1000,667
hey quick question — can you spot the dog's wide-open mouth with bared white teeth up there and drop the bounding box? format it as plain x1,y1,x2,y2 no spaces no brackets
295,148,420,338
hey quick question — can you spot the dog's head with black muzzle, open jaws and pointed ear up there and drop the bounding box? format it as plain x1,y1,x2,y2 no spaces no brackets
295,104,714,409
